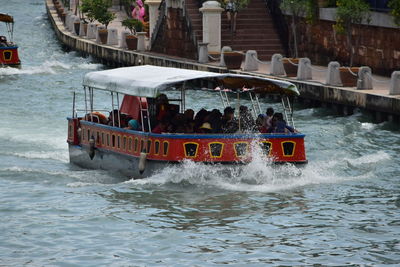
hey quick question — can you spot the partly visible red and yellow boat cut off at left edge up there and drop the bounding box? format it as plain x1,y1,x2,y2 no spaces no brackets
0,13,21,67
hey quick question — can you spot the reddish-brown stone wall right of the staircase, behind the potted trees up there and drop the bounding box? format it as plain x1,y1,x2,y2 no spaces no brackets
292,14,400,76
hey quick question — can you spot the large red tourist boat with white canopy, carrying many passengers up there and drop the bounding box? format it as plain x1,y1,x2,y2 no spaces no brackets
67,65,307,178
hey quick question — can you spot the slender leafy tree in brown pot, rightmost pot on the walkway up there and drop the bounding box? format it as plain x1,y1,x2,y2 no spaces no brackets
333,0,371,87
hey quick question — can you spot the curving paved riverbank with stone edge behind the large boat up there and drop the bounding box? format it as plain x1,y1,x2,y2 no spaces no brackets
46,0,400,119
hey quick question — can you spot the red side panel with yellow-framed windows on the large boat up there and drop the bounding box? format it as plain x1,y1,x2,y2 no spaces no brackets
72,119,307,163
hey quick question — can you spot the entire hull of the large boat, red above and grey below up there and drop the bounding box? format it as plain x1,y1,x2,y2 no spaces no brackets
68,119,307,177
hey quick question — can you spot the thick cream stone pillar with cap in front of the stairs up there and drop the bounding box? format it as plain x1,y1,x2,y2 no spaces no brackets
199,1,224,52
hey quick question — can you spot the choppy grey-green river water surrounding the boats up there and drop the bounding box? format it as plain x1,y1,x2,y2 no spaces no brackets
0,0,400,266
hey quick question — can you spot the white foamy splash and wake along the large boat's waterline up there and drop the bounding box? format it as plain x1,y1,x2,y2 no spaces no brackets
126,143,378,192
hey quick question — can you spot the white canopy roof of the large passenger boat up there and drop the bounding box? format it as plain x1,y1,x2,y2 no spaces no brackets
83,65,299,97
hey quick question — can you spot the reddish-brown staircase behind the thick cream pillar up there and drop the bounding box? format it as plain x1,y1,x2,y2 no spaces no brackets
185,0,284,60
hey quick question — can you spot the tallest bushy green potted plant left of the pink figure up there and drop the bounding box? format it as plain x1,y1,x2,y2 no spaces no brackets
90,0,115,44
